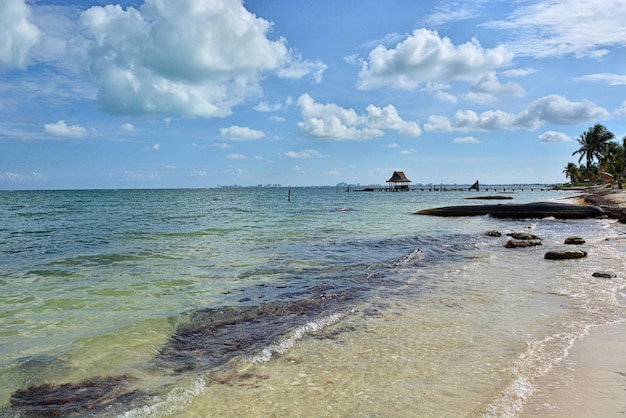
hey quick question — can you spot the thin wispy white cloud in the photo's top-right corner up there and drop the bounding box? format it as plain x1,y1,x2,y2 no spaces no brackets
487,0,626,57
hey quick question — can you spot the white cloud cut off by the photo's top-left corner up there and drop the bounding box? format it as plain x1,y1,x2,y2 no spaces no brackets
0,0,41,71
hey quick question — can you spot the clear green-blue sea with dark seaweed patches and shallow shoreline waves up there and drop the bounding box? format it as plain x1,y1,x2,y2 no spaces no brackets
0,185,626,417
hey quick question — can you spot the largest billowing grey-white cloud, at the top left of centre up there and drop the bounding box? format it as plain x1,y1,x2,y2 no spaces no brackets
80,0,325,117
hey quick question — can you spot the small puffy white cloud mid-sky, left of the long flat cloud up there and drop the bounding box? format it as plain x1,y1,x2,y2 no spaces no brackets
298,94,421,140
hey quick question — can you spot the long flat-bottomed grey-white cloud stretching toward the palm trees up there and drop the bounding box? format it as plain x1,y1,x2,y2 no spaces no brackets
424,94,609,131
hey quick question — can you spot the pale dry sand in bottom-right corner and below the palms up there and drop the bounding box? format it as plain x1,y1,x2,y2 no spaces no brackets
521,189,626,418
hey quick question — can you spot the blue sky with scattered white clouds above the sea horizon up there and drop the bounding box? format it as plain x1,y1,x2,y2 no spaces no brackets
0,0,626,189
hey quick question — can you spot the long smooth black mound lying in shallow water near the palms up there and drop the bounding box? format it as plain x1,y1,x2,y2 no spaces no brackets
415,202,606,219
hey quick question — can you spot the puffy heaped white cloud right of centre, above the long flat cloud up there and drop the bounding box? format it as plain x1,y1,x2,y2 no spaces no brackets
359,29,513,90
